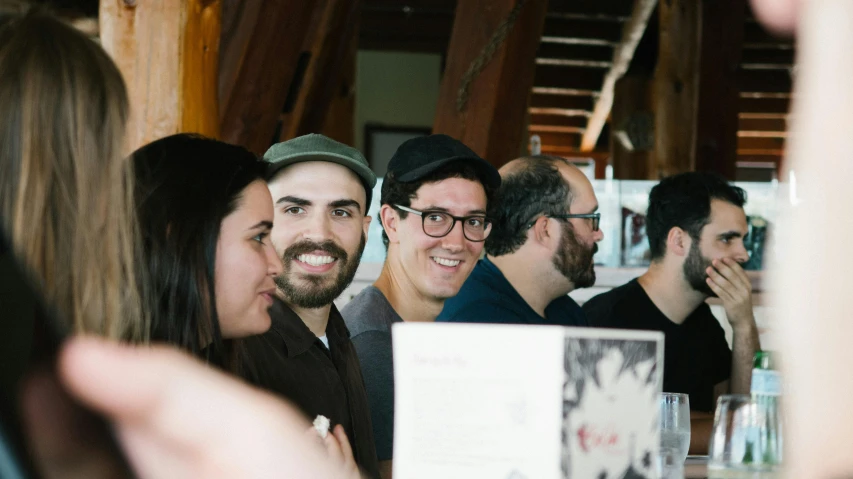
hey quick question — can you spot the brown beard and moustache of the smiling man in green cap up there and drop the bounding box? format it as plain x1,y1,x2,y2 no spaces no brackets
275,234,367,309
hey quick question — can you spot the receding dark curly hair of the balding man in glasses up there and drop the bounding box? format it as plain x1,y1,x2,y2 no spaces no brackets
485,155,572,256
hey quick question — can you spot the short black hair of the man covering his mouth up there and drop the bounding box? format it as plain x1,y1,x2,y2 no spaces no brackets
646,172,746,260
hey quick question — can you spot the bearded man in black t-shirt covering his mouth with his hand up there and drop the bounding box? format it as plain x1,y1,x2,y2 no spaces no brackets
584,172,759,453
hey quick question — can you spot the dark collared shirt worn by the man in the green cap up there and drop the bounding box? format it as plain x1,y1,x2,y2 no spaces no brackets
244,298,379,477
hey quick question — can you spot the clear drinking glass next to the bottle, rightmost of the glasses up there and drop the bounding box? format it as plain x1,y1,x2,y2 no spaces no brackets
708,394,782,472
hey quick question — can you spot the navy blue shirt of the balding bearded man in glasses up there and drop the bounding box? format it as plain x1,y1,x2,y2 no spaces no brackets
436,258,589,326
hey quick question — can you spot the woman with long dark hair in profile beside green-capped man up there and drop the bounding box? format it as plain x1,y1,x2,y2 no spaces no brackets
131,134,282,372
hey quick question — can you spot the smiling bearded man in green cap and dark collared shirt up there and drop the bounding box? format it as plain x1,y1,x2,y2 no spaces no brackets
245,134,378,477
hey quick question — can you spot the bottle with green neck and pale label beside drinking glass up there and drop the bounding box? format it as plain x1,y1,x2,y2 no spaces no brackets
750,351,782,467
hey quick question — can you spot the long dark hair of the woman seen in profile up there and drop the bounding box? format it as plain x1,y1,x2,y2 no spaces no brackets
131,134,266,372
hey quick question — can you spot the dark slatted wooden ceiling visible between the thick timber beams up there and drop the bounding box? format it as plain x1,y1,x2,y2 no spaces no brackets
359,0,794,169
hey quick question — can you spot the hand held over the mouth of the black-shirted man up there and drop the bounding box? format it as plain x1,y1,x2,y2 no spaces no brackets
705,258,755,328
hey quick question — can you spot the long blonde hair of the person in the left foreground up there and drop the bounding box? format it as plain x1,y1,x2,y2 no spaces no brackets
0,12,149,341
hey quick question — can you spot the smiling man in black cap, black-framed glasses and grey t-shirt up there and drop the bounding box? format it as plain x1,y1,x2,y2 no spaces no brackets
342,135,500,479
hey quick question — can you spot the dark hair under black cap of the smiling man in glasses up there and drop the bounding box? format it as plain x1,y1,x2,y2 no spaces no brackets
379,161,495,249
